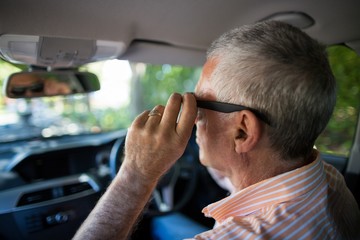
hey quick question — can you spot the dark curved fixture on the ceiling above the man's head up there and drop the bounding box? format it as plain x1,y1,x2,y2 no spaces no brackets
262,12,315,29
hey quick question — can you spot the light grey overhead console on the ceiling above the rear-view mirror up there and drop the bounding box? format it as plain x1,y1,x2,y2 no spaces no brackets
0,34,126,68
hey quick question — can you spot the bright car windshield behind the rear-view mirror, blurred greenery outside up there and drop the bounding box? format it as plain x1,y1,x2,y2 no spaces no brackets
0,60,201,143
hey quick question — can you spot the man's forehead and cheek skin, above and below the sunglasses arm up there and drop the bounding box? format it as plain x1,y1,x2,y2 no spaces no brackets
195,59,234,171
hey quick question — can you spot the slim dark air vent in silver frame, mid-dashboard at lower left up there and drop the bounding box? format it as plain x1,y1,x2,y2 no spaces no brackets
17,182,92,207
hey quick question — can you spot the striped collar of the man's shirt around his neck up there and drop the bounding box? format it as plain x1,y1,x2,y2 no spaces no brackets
202,153,325,223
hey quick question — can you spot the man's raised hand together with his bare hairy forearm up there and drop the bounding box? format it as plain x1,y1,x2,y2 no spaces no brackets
74,94,197,239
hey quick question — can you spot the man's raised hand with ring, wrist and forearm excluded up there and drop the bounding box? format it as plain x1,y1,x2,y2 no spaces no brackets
123,93,197,181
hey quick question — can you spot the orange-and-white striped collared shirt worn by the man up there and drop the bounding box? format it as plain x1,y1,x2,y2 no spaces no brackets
195,154,360,239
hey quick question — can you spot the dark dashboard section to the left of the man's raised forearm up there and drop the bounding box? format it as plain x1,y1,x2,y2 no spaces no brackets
0,131,126,239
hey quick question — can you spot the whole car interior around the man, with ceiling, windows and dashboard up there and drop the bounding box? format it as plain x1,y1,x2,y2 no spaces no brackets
0,0,360,239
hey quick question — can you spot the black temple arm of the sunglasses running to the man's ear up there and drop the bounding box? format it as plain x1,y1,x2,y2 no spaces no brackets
196,100,271,126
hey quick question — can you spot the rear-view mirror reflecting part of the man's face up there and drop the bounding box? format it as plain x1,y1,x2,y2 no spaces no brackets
4,71,100,98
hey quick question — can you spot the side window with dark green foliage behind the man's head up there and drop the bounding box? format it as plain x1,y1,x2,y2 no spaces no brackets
315,46,360,157
